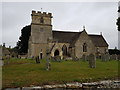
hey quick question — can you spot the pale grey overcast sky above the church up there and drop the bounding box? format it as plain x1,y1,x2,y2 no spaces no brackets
0,2,118,48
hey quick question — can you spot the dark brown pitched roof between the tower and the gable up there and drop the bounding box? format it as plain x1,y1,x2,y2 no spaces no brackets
52,31,79,43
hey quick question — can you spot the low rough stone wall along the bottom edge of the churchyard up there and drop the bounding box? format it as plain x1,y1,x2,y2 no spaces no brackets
5,80,120,90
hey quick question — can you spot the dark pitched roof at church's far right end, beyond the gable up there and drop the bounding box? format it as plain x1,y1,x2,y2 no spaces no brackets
88,34,108,47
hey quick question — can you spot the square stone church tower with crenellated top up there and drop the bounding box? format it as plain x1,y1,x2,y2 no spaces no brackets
28,11,52,58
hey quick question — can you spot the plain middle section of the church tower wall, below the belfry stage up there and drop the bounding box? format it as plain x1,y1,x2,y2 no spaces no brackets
31,24,52,43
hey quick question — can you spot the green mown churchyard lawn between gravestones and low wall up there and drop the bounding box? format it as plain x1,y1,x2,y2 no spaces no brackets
2,59,120,88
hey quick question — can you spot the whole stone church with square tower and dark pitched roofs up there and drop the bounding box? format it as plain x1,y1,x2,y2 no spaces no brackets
28,11,108,59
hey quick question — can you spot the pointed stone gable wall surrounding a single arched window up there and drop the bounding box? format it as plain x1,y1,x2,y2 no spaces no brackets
75,31,95,58
